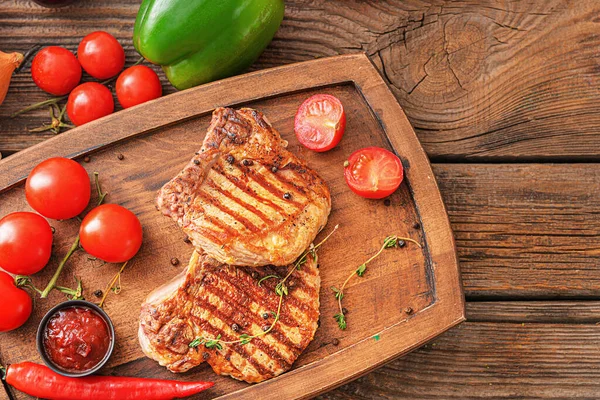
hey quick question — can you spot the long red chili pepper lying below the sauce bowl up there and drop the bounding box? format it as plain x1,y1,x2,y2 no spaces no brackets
6,362,214,400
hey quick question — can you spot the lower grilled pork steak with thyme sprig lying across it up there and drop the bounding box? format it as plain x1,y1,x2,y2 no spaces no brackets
138,252,321,383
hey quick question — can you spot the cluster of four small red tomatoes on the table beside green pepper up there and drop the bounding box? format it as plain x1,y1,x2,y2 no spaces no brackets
31,31,162,126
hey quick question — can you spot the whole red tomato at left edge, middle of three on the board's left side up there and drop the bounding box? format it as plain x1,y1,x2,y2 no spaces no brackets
0,212,52,275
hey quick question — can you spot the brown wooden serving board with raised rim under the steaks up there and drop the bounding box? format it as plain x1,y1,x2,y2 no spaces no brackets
0,54,464,399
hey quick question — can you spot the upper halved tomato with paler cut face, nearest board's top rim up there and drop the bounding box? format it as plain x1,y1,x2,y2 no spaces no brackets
294,94,346,152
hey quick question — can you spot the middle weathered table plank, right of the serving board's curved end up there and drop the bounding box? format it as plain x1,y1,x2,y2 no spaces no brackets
434,164,600,298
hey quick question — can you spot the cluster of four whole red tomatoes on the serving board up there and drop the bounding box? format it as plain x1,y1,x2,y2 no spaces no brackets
0,157,142,332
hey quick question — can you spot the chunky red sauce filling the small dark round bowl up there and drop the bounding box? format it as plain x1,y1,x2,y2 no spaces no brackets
44,307,112,372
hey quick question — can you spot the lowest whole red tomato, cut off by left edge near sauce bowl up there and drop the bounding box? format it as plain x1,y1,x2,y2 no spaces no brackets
0,271,33,332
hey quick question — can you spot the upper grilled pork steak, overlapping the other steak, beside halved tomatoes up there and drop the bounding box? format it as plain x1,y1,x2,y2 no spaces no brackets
157,108,331,266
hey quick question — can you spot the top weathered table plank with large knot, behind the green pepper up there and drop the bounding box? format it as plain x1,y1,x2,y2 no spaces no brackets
0,0,600,161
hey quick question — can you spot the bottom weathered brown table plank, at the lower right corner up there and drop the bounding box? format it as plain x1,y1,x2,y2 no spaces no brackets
319,318,600,400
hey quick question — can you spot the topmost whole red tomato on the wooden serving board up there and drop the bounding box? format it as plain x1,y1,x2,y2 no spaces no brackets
25,157,91,219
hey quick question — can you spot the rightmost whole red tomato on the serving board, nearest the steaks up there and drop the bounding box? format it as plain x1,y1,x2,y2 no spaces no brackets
79,204,142,263
